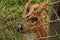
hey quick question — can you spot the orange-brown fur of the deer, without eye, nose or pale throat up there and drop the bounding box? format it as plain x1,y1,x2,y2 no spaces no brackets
23,2,48,40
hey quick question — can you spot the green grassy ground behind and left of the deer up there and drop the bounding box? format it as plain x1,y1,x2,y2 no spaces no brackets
0,0,46,40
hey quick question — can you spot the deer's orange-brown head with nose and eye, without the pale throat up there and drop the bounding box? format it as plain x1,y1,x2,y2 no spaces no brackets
18,3,46,40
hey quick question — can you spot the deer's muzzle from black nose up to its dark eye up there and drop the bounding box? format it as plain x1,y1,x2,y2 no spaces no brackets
18,17,39,32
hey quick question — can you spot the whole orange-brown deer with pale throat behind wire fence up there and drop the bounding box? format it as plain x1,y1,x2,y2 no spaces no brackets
18,2,48,40
